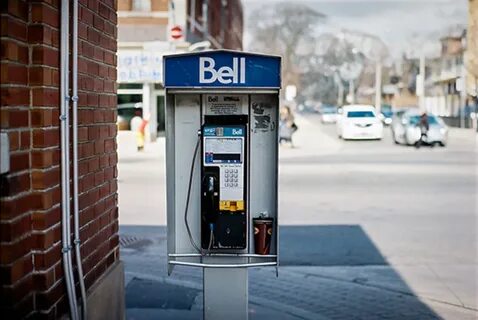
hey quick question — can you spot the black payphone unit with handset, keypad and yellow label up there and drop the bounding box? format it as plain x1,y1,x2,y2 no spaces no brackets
201,121,247,251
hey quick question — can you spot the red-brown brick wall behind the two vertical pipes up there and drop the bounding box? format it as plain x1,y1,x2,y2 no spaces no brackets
0,0,119,319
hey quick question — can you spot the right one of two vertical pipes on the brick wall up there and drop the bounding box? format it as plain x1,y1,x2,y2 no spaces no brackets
71,0,87,320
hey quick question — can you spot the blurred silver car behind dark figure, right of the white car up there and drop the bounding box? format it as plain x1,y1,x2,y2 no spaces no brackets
392,110,448,147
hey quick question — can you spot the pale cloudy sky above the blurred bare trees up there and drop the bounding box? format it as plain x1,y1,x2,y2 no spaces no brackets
242,0,468,58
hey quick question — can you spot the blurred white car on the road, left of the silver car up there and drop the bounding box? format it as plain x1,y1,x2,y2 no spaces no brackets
337,105,383,140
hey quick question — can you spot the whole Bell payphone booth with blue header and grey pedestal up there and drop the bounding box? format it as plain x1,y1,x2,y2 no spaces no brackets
164,50,281,319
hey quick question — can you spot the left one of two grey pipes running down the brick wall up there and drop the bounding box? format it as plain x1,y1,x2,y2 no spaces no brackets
60,0,78,320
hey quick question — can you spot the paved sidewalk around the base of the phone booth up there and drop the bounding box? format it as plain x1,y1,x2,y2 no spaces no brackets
120,227,478,320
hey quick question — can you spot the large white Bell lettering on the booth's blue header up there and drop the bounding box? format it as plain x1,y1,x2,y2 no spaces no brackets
199,57,246,84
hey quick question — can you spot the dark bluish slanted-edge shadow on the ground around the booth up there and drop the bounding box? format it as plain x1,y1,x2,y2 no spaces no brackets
120,225,441,320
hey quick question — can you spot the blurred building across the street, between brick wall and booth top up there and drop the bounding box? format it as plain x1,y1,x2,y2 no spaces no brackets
118,0,243,141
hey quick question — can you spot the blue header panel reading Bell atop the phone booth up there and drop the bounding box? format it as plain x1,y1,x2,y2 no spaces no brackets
164,50,281,89
